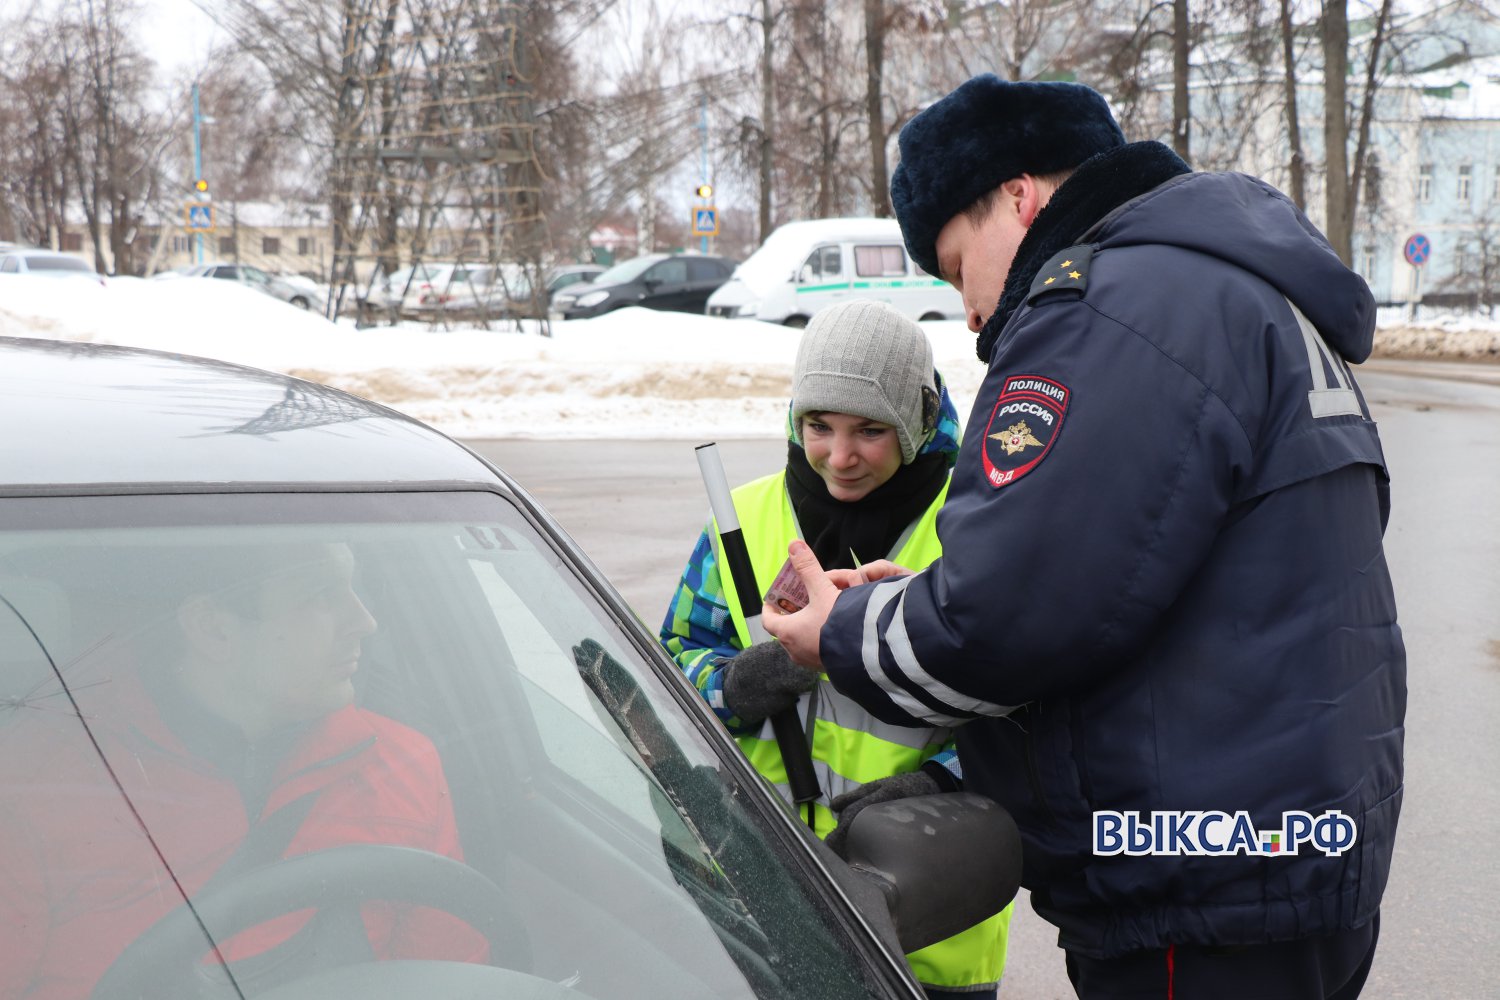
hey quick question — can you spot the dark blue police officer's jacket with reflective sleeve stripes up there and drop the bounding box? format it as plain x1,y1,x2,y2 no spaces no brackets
821,174,1406,958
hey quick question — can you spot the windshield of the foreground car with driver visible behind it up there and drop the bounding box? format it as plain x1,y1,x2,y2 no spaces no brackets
0,492,887,1000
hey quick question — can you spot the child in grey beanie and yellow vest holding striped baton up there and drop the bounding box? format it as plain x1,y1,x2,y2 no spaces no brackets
660,301,1011,1000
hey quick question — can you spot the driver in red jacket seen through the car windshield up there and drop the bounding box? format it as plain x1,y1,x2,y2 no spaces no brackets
0,543,488,997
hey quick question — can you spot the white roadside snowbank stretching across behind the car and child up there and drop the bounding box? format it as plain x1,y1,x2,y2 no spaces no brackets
0,277,1500,438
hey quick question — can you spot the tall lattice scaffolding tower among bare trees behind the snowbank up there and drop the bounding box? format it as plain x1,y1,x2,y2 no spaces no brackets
330,0,546,324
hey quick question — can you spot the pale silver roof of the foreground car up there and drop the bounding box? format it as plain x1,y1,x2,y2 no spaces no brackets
0,337,512,496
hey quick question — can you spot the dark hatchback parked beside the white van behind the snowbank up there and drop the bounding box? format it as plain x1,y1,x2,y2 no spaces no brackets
552,253,735,319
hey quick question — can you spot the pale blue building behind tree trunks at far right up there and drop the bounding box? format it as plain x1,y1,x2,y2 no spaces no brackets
1155,0,1500,306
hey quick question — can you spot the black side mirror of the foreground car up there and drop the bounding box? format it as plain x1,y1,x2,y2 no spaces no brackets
846,792,1022,952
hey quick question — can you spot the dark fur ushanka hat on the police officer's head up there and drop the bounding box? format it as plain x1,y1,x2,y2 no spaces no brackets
891,73,1125,274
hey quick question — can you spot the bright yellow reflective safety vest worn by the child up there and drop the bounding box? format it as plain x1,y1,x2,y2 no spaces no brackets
713,469,1013,990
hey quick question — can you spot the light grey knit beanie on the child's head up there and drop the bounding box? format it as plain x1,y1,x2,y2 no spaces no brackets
792,300,938,465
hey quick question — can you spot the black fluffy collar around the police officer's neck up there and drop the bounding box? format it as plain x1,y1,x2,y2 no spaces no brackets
977,142,1191,364
